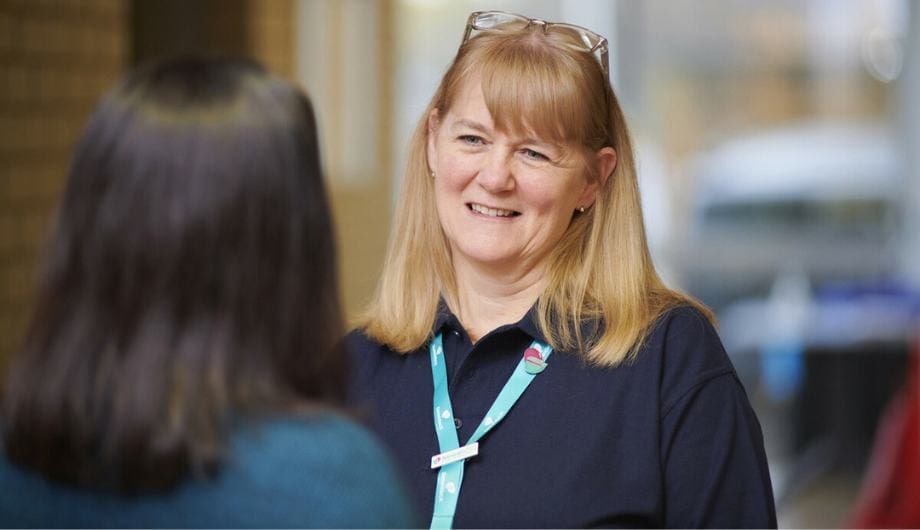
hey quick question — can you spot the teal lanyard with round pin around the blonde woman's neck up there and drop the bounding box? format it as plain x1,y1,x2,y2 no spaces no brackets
428,334,553,529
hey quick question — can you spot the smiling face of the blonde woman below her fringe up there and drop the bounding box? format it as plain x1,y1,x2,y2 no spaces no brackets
428,76,598,272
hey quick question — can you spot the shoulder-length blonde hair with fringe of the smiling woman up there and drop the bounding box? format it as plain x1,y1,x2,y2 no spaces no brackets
358,22,713,366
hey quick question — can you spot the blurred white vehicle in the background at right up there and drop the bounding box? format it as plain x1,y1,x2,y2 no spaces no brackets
674,123,903,313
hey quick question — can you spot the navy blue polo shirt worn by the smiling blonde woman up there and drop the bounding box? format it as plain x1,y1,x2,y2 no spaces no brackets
348,307,776,528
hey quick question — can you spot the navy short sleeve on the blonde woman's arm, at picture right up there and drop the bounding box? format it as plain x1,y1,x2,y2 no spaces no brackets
660,308,777,528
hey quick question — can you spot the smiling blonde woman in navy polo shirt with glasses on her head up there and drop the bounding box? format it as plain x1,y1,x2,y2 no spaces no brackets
349,11,776,528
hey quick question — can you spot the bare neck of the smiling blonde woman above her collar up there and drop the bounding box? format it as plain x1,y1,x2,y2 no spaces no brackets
454,256,546,343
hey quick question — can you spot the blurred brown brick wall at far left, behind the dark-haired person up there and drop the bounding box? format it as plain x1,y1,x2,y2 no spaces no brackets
0,0,128,370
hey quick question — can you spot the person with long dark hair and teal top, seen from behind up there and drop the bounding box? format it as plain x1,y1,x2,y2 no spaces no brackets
0,58,414,527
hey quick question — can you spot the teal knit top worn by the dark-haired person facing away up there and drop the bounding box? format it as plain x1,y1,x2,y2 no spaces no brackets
0,414,419,528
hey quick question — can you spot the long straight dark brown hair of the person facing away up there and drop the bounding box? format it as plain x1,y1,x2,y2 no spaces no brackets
4,58,344,490
